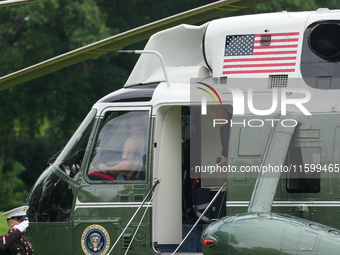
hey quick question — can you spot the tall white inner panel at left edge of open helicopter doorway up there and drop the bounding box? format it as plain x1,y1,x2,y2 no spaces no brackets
153,106,182,244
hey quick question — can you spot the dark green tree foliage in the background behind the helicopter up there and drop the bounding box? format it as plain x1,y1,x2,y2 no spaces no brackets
0,0,339,210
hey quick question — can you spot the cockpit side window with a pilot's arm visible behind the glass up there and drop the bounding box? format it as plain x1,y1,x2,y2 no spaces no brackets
88,111,149,181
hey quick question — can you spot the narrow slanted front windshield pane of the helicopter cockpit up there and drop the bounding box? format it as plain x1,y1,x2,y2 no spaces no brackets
55,110,96,178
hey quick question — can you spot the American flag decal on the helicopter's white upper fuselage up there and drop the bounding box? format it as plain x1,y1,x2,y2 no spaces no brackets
223,32,299,75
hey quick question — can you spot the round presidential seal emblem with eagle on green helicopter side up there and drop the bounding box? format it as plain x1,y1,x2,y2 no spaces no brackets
81,224,110,255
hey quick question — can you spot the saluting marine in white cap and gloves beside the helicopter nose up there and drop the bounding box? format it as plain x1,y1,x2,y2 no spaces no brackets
0,206,33,255
